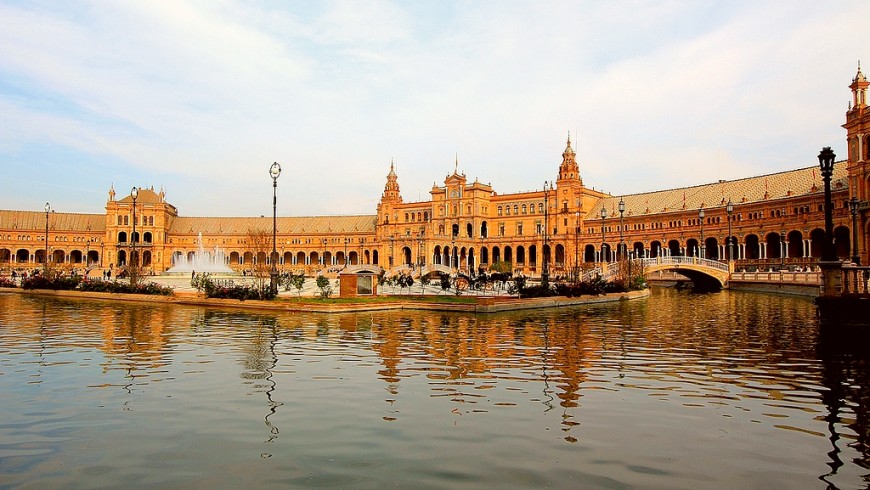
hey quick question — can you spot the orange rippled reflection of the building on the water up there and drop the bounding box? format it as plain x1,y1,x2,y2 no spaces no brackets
7,292,870,486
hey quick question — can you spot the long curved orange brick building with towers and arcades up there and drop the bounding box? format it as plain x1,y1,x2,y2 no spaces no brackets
0,65,870,276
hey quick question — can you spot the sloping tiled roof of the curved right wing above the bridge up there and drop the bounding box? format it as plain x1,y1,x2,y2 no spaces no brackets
586,161,848,220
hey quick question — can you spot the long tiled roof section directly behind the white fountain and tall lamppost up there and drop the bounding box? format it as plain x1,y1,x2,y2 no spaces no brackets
169,215,376,235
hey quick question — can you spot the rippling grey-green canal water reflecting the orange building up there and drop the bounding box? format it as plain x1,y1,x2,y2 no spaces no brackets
0,289,870,489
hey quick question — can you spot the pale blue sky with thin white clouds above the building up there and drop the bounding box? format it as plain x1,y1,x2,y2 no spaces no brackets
0,0,870,216
